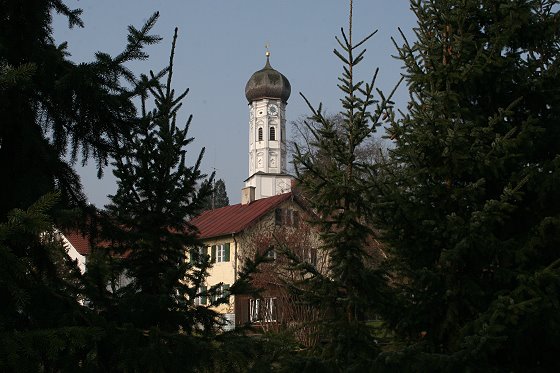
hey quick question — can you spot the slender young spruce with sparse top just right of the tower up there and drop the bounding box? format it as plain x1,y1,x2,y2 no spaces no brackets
294,2,400,371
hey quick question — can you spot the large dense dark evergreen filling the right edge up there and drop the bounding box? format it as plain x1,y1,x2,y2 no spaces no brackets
376,0,560,372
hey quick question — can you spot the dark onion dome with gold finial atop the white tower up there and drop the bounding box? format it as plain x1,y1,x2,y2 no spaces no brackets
245,51,292,103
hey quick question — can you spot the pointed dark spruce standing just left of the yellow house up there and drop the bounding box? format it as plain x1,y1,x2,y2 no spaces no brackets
87,30,223,371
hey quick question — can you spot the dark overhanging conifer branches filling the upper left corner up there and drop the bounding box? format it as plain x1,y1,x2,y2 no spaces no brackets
0,0,159,215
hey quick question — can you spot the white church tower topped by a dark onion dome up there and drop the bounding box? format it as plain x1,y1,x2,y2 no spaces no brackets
245,51,293,199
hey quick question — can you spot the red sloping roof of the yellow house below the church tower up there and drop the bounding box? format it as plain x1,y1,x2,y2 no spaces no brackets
190,192,292,238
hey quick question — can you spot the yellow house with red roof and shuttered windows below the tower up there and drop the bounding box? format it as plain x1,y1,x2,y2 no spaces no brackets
191,192,319,327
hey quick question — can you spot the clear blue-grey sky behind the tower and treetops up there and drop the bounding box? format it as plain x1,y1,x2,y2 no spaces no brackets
54,0,415,206
